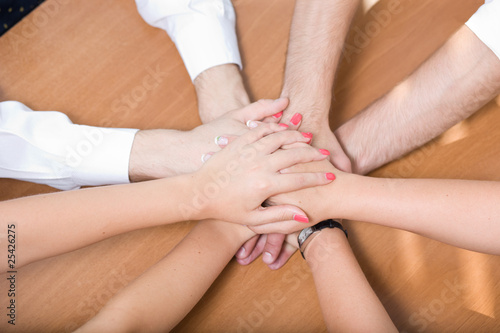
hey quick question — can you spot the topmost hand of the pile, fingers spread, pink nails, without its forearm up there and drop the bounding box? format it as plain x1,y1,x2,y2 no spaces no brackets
189,123,335,228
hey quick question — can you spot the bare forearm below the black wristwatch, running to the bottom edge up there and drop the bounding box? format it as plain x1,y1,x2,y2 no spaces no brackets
304,229,397,332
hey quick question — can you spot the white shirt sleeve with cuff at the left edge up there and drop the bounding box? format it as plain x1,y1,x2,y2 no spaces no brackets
0,101,138,190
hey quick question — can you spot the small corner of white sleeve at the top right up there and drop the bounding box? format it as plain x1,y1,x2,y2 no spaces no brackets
465,0,500,58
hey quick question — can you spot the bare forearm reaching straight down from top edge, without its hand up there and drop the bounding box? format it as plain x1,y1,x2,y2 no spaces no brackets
282,0,359,123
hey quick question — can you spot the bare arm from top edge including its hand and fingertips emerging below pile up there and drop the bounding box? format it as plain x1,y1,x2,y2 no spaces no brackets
241,0,359,269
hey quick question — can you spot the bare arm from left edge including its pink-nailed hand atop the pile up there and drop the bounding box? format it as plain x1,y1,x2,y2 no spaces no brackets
0,124,331,269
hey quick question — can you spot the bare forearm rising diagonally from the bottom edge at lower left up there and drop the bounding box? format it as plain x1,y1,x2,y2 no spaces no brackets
81,221,252,332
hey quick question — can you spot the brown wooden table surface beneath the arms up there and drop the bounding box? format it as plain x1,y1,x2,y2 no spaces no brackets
0,0,500,332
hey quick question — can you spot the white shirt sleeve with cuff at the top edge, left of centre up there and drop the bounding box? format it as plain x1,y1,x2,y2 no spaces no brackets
135,0,242,81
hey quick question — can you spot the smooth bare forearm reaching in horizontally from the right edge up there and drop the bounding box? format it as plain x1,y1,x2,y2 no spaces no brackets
328,175,500,254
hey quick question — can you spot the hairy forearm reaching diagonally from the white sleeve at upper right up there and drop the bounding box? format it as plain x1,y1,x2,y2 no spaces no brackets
335,26,500,174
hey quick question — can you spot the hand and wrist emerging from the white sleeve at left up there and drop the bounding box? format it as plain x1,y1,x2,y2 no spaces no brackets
129,98,288,182
